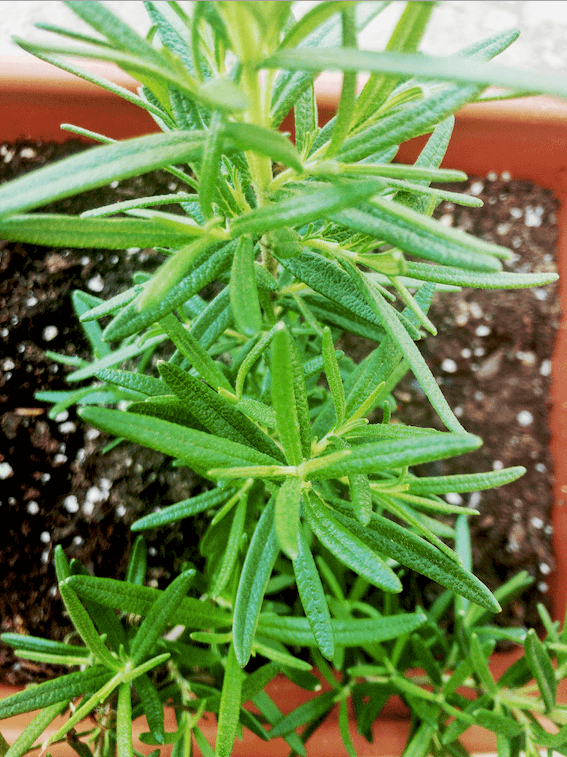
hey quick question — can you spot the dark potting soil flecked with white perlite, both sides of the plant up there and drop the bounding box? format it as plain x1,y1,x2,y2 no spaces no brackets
0,142,559,683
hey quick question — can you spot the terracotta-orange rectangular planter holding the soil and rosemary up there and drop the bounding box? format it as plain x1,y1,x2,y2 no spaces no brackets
0,57,567,757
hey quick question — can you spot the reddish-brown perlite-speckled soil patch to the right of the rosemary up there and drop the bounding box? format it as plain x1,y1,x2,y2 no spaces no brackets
412,174,561,625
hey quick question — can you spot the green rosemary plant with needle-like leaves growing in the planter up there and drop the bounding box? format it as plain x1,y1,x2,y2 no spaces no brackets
0,1,567,757
